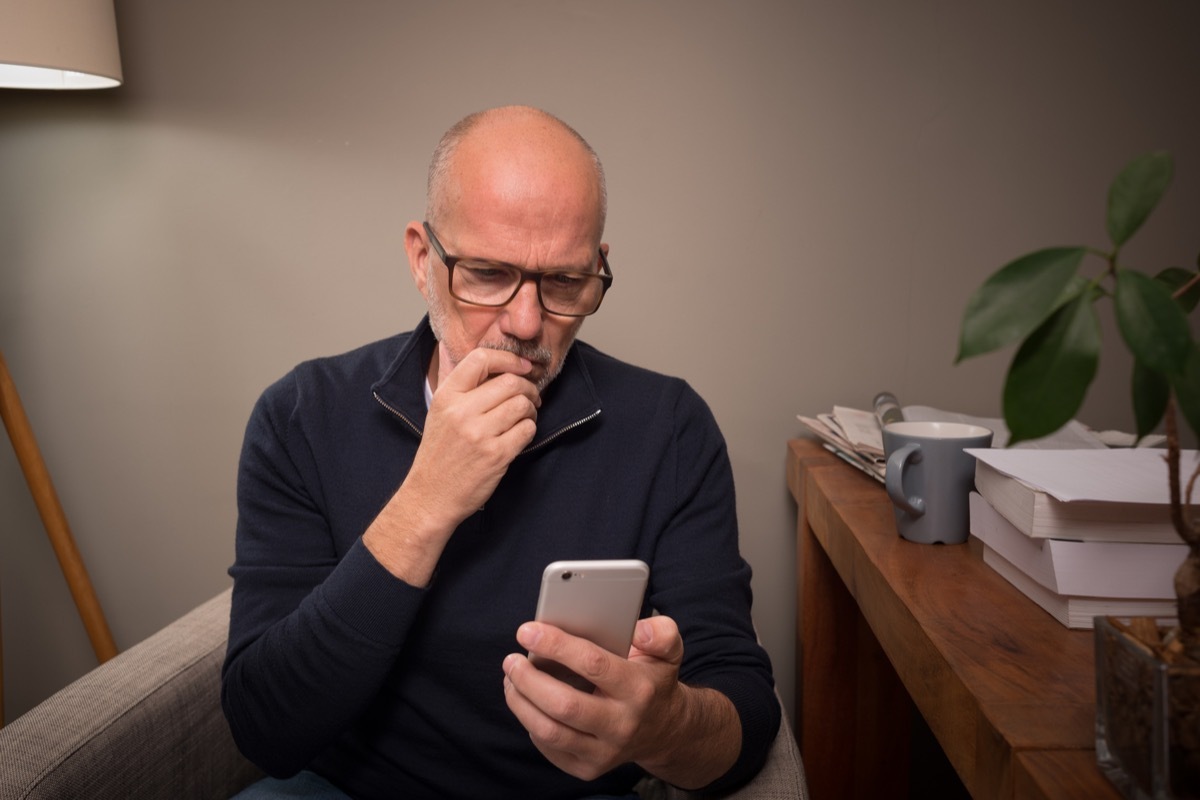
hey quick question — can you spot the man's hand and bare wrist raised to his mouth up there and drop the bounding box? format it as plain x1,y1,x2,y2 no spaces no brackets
362,348,541,587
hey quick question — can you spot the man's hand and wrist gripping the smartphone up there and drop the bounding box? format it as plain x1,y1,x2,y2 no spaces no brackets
504,616,742,788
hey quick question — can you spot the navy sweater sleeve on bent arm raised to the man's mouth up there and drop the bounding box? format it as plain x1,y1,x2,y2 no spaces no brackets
221,378,424,776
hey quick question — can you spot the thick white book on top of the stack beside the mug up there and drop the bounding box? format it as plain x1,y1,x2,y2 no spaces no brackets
968,449,1196,545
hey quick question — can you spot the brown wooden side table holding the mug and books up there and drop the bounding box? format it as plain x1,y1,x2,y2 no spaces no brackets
787,439,1120,800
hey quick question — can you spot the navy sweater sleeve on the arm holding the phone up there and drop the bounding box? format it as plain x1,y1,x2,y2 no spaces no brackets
652,386,780,792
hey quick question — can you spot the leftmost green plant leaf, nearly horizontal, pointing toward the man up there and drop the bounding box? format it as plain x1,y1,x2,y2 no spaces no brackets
955,247,1086,362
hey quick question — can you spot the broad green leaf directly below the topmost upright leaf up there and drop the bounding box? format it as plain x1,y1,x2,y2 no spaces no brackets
1112,270,1192,373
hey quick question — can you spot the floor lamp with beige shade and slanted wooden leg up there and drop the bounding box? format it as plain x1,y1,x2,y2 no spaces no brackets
0,0,124,726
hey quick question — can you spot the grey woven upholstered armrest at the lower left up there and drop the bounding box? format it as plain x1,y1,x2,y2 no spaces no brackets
0,590,258,800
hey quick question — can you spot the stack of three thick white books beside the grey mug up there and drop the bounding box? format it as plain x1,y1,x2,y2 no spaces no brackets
970,449,1198,628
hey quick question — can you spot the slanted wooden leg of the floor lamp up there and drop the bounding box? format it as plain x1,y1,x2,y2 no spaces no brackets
0,351,116,726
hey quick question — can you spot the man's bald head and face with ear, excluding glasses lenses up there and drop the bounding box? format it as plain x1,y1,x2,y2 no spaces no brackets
404,118,602,391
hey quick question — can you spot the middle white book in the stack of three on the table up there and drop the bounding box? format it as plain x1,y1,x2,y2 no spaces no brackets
971,492,1188,600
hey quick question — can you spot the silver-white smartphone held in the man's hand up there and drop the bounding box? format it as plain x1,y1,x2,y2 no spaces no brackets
530,559,650,692
